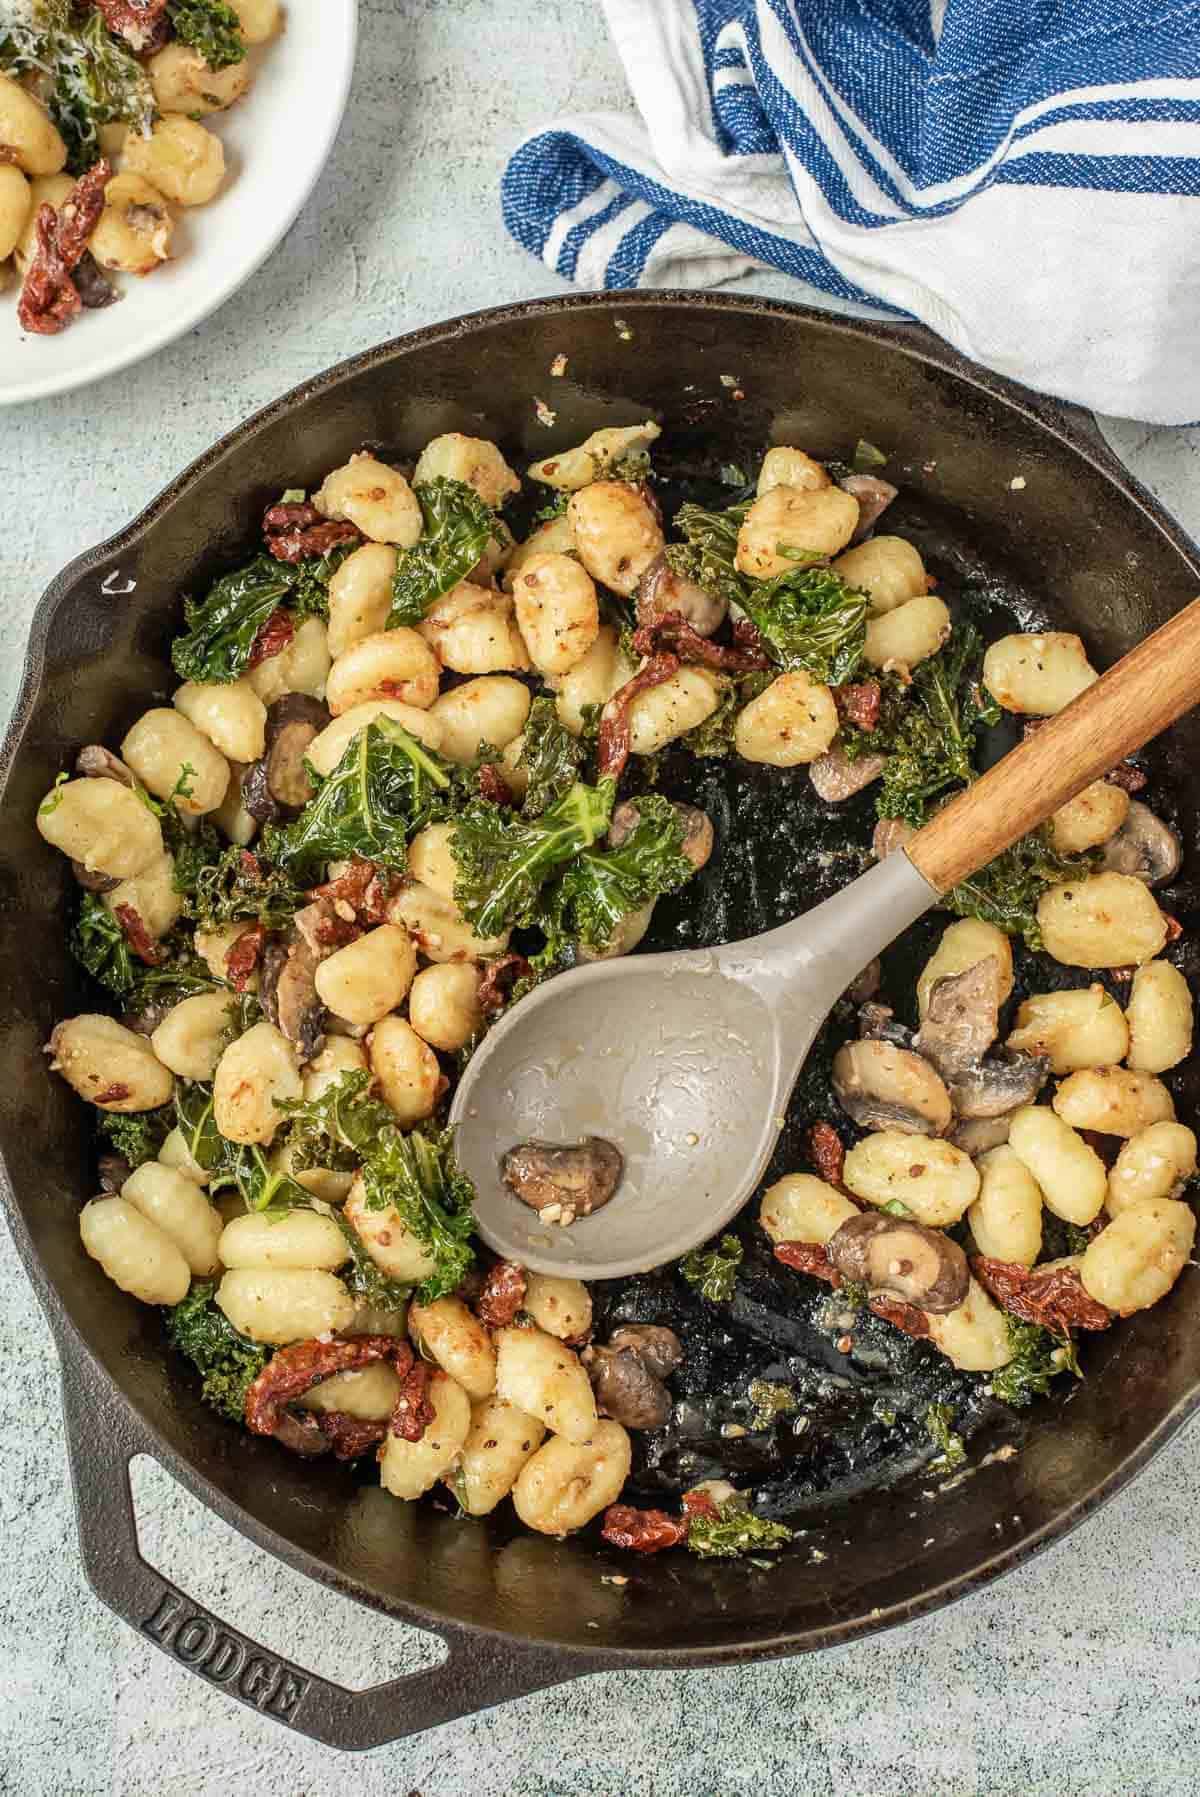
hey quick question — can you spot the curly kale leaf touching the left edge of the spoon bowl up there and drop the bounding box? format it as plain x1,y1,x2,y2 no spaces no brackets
363,1129,474,1305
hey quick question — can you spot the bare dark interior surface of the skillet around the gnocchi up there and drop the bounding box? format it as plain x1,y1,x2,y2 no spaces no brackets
0,297,1200,1657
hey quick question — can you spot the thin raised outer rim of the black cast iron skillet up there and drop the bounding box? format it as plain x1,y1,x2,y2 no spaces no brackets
0,289,1200,1674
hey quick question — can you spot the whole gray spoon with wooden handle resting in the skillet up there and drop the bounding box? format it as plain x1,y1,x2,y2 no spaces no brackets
451,600,1200,1279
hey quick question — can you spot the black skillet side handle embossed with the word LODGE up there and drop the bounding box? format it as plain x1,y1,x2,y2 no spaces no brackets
63,1366,574,1750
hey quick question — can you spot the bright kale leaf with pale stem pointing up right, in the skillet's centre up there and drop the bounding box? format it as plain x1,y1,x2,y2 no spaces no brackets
451,780,616,936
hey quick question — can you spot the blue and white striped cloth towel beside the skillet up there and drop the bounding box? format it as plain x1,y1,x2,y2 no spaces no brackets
503,0,1200,424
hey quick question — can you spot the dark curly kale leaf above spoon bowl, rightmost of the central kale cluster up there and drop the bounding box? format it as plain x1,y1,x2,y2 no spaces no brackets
535,792,695,949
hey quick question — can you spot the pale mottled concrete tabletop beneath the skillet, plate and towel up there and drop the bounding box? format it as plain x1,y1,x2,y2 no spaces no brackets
0,0,1200,1797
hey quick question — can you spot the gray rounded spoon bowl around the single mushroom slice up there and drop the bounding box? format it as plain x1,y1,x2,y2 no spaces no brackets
451,952,794,1279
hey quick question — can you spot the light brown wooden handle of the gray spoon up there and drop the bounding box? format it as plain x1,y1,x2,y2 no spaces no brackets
905,598,1200,893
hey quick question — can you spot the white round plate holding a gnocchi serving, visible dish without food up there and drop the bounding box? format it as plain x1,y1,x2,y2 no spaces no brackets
0,0,357,406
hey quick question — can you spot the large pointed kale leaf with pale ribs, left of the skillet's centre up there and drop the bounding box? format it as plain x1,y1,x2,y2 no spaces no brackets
262,715,456,879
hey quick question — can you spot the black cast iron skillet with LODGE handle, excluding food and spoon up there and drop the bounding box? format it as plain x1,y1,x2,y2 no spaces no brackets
0,295,1200,1747
